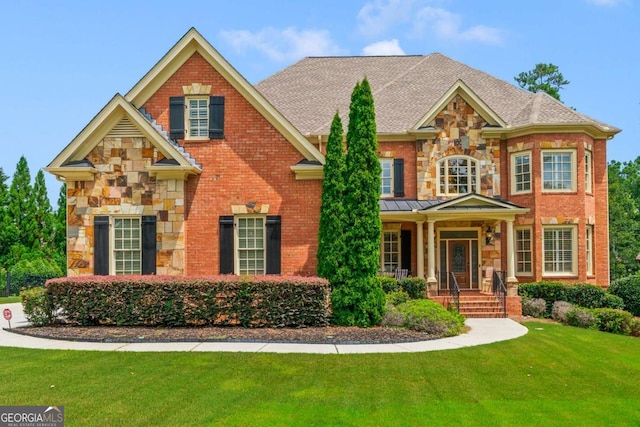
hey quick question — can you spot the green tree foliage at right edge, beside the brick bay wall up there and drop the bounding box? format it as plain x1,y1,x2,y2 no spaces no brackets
608,157,640,281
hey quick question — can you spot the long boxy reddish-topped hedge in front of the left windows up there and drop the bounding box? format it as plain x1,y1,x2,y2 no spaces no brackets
46,275,330,328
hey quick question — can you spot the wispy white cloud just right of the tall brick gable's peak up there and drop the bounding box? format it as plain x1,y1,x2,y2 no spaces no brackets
220,27,347,62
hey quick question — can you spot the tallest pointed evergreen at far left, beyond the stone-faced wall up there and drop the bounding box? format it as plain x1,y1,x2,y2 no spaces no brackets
8,156,36,256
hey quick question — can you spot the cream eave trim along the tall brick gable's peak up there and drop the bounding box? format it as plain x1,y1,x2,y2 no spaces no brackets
125,28,324,164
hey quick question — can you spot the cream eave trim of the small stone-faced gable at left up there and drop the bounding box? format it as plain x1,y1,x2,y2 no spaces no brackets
45,94,201,179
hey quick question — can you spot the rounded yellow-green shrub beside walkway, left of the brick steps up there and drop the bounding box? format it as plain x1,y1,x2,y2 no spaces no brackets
396,299,464,337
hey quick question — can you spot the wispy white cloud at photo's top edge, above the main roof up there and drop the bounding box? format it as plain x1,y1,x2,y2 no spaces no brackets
358,0,502,44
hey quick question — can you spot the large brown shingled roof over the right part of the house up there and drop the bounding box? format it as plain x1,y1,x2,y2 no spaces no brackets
256,53,620,137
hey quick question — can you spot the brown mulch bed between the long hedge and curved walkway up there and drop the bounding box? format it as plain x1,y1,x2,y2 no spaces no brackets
5,325,440,344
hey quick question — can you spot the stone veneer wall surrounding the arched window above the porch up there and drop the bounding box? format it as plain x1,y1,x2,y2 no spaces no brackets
416,95,500,200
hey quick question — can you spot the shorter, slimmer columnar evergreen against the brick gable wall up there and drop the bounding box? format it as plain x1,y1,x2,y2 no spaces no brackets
317,112,346,285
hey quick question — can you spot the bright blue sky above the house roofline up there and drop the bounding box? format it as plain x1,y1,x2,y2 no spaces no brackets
0,0,640,200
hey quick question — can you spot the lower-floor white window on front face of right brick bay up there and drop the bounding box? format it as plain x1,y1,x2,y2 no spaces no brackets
543,226,577,276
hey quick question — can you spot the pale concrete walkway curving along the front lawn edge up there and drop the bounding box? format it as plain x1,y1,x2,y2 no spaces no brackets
0,303,528,354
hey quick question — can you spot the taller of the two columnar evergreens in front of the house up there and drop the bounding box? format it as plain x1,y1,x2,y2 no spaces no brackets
331,78,384,327
